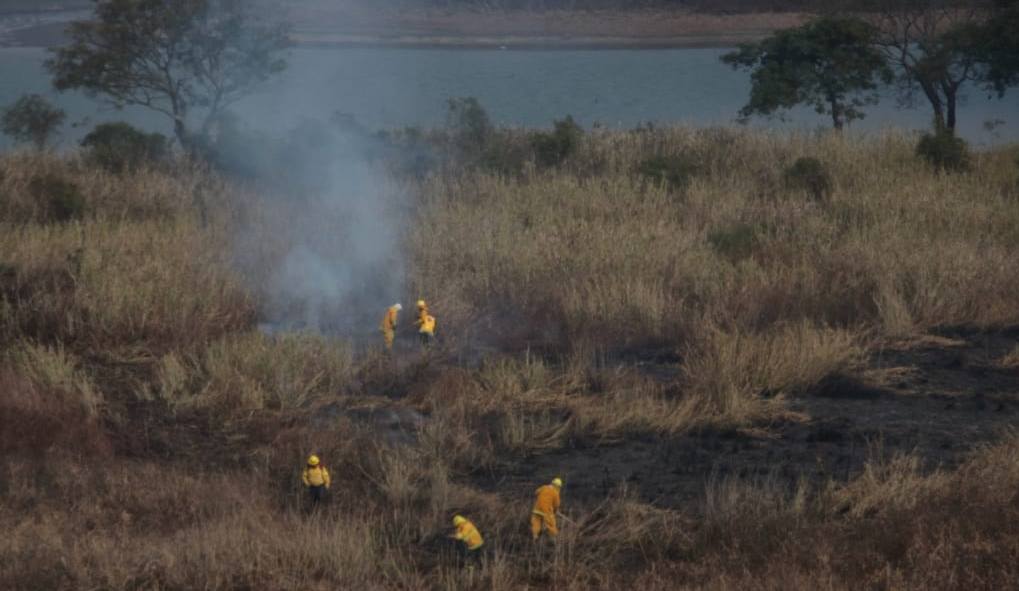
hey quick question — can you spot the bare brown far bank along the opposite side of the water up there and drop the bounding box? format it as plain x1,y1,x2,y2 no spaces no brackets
0,8,805,50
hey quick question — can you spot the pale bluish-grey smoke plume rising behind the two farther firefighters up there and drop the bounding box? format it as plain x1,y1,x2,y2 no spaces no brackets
223,113,408,337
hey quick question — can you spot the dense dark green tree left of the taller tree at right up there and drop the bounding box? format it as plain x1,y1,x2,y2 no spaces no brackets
721,16,891,129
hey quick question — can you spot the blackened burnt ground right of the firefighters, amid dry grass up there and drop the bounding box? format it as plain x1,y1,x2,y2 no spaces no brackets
473,328,1019,512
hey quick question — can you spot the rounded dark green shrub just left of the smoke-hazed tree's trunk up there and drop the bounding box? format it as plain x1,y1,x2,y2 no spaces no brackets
82,122,169,173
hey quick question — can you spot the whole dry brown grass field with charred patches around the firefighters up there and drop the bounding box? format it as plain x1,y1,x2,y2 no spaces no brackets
0,128,1019,590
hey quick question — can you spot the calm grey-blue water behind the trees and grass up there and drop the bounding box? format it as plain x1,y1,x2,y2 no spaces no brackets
0,48,1019,146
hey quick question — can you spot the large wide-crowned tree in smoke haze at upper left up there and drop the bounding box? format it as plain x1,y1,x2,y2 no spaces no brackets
47,0,288,148
